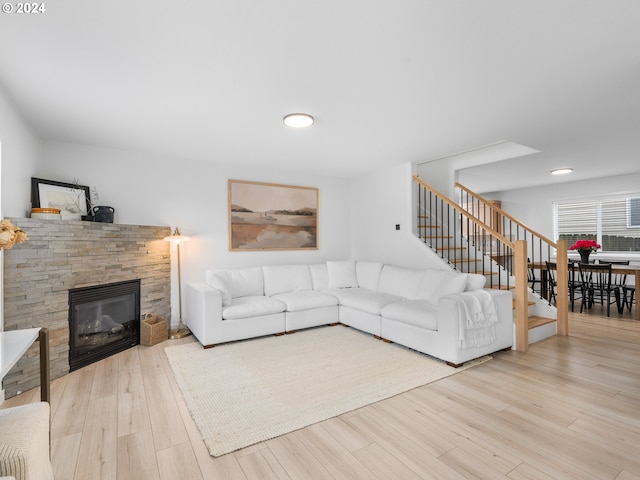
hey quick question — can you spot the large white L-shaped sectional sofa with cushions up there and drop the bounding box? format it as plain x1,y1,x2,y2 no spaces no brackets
184,260,513,365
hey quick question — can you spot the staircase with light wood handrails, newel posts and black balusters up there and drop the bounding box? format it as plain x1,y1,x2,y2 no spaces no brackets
413,176,568,351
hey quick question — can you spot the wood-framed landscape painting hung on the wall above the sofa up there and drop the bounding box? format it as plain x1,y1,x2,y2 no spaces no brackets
229,180,318,251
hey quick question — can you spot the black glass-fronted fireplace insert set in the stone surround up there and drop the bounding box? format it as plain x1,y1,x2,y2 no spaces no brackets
69,280,140,372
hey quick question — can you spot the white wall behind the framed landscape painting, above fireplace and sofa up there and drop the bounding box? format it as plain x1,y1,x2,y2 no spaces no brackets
34,142,351,318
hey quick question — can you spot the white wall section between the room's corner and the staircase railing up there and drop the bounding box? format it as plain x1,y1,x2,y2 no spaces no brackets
351,163,448,269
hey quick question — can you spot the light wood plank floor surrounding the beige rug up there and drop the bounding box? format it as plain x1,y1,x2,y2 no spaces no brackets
2,309,640,480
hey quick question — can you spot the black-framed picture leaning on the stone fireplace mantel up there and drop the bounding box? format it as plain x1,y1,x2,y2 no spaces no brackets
31,177,91,220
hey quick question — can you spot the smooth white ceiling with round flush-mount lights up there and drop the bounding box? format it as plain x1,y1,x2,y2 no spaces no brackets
0,0,640,192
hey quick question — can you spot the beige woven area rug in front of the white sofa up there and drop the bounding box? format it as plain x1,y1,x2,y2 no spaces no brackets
165,326,491,457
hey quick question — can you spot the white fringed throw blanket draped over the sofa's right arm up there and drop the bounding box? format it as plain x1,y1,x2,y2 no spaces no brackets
451,290,498,348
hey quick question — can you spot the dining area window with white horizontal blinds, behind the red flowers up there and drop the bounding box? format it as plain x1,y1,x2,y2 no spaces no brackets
553,193,640,252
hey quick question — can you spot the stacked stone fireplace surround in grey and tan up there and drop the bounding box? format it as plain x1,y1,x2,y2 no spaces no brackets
3,218,171,398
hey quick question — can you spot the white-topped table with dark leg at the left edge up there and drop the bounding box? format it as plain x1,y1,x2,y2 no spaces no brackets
0,328,51,403
